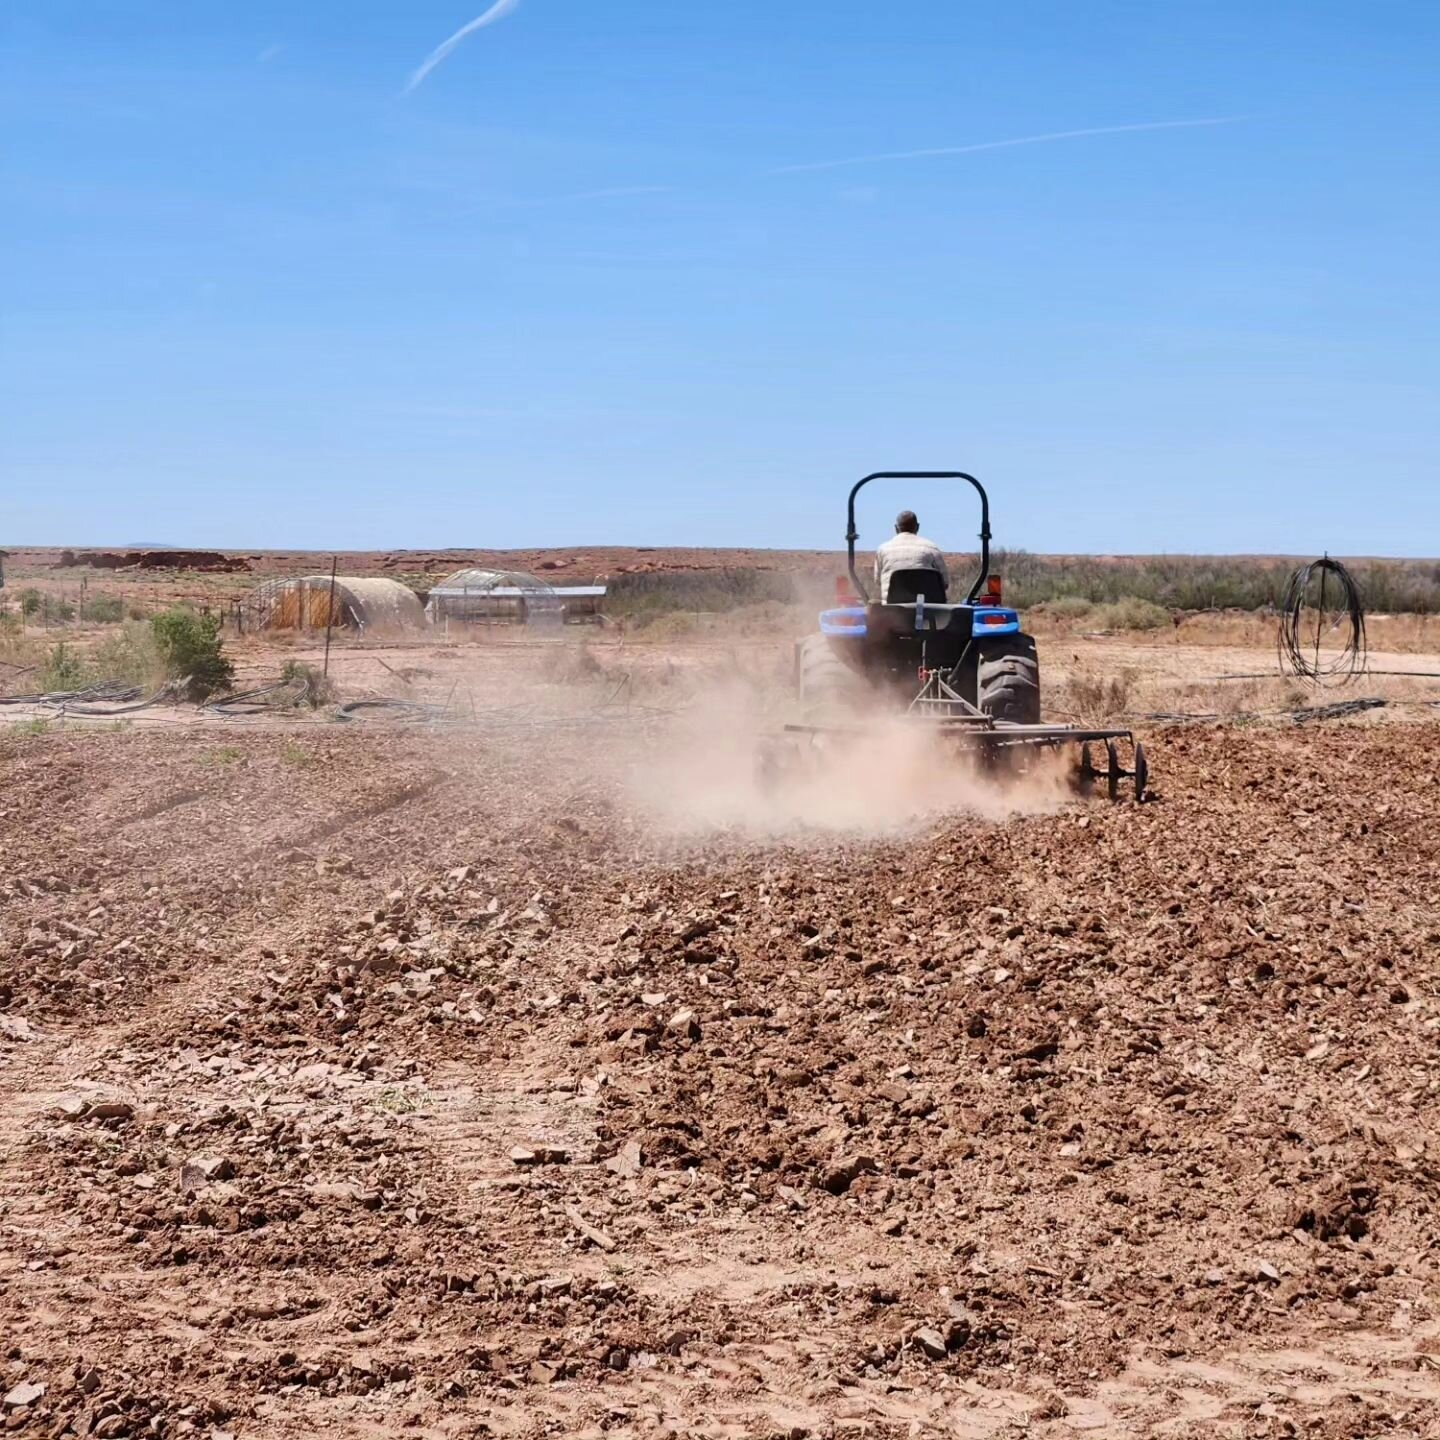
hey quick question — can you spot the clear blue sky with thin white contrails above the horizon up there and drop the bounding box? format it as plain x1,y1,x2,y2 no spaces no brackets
0,0,1440,554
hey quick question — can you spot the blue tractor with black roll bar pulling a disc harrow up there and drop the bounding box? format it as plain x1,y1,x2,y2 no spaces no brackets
786,471,1149,799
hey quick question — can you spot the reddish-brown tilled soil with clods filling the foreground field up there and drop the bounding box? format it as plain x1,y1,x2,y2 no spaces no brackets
0,719,1440,1440
